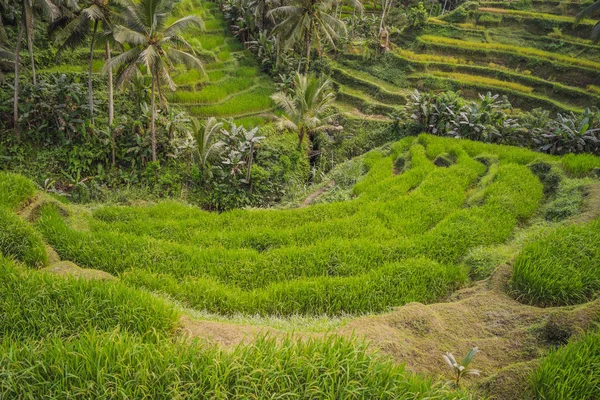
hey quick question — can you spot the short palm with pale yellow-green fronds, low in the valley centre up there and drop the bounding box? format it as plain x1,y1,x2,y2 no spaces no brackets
271,73,335,147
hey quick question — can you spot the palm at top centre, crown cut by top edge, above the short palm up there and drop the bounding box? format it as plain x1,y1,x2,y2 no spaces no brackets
269,0,346,74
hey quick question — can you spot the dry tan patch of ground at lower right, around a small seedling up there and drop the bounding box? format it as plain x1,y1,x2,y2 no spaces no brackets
339,265,600,399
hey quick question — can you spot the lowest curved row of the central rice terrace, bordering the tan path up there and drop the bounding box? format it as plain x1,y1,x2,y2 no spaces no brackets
123,258,466,316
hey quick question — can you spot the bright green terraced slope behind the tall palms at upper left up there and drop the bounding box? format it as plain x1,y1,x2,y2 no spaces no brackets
41,0,276,125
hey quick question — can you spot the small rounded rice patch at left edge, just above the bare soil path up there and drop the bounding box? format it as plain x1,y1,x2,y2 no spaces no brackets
0,207,48,268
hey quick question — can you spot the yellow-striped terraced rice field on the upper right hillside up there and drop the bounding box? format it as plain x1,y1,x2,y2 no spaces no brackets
333,1,600,115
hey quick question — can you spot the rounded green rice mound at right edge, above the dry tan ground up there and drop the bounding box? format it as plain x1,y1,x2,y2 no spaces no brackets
511,220,600,306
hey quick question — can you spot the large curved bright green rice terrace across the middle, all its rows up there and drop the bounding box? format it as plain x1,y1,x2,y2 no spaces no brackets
31,136,543,315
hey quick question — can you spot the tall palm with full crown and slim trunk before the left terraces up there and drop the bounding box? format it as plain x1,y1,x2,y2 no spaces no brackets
110,0,203,161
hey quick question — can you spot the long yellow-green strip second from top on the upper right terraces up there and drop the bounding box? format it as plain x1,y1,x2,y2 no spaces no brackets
419,35,600,70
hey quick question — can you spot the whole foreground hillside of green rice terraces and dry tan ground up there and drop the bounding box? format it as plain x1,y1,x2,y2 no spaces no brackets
0,135,600,398
